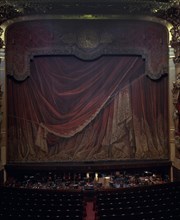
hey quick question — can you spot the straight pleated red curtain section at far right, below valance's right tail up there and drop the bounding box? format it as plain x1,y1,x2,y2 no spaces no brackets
131,77,169,159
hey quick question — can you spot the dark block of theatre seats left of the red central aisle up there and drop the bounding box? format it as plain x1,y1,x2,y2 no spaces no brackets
0,189,86,220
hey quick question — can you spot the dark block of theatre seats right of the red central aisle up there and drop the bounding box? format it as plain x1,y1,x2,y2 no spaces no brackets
95,183,180,220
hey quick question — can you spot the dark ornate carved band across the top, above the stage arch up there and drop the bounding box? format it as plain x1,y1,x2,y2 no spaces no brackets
0,0,180,47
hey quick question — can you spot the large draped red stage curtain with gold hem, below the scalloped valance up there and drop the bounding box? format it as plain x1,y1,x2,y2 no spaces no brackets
7,56,167,161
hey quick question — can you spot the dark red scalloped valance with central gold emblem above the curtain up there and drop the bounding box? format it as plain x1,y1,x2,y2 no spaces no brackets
6,20,168,80
